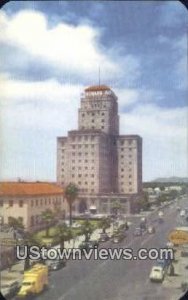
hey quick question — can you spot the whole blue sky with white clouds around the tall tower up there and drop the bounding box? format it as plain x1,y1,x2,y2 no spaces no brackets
0,1,188,181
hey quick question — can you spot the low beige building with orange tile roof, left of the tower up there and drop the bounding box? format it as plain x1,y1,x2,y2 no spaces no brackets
0,182,68,231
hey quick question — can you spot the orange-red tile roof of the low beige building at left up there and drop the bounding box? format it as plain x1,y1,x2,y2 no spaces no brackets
0,182,63,196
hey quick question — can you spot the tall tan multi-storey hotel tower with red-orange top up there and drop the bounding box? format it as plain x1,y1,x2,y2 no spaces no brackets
57,85,142,213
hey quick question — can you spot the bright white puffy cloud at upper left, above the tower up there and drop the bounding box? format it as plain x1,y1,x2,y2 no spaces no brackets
0,10,120,81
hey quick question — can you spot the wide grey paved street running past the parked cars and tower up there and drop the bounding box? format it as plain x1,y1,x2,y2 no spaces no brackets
31,198,188,300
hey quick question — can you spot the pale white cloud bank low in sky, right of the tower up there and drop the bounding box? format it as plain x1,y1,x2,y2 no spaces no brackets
120,103,188,180
